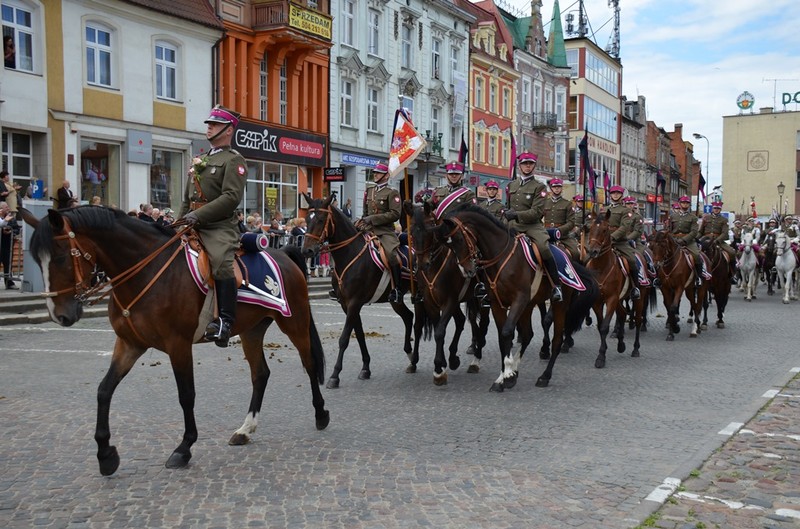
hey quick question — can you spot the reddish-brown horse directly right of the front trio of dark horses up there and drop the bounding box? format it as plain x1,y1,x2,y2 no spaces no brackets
586,214,656,368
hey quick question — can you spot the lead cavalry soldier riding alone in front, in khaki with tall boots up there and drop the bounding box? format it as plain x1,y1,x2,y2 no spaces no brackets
181,105,247,347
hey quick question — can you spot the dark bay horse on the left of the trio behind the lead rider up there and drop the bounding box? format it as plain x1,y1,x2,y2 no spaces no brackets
303,195,414,388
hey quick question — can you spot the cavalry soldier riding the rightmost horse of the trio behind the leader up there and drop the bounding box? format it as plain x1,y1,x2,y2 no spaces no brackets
503,152,563,301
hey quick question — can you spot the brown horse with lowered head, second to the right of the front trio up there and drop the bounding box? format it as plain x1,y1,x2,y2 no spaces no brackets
648,231,708,342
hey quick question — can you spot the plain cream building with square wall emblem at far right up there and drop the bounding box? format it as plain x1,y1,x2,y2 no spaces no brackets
722,107,800,219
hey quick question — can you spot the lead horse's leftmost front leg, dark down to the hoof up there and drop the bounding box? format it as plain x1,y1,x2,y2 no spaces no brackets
94,338,148,476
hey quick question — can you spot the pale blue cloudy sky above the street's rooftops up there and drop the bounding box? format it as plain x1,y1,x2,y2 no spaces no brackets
506,0,800,187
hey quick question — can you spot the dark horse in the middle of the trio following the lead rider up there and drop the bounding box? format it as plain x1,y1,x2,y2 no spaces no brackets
410,200,489,386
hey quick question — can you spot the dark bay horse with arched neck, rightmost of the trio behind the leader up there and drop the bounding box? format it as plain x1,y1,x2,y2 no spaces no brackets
434,206,599,391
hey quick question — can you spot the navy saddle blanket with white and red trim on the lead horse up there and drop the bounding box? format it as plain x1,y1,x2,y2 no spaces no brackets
186,246,292,317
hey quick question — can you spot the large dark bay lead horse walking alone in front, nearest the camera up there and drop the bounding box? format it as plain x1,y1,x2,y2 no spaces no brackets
22,206,330,476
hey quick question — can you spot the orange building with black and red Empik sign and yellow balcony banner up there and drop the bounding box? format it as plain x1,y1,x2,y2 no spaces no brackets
214,0,332,219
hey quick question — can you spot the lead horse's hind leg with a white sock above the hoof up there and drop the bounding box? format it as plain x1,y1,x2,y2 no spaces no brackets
228,320,272,446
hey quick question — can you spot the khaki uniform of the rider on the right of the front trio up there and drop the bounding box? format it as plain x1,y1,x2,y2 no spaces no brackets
508,175,553,260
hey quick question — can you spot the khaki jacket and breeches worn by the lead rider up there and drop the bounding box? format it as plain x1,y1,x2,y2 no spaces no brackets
181,146,247,279
